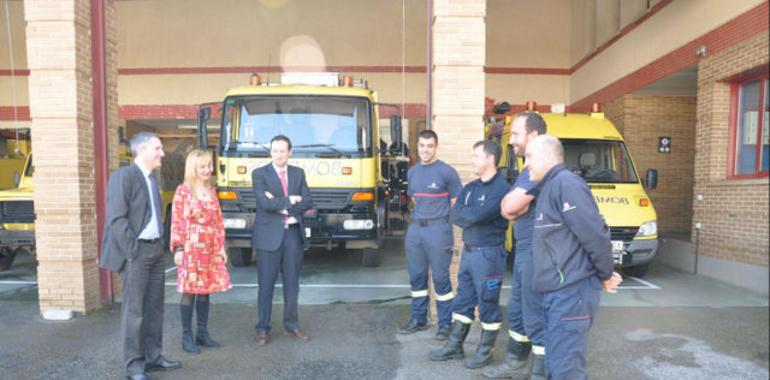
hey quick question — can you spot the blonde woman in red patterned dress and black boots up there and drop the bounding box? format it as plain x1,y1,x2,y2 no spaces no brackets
171,150,231,354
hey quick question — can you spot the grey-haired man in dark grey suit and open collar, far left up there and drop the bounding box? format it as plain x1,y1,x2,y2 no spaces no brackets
99,132,181,380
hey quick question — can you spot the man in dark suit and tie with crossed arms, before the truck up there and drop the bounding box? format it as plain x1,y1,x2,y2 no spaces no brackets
251,135,313,346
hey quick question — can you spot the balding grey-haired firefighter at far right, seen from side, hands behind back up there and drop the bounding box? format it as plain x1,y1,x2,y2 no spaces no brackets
526,135,622,380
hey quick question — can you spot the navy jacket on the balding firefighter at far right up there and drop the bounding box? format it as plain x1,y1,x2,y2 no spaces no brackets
532,164,614,292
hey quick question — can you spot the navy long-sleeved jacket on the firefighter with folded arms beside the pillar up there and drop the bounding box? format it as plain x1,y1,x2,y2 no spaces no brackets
450,173,508,247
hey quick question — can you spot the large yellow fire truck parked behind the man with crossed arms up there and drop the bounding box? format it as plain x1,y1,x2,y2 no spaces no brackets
198,73,401,266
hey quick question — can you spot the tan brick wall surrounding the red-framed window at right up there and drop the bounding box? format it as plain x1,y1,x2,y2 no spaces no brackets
693,30,770,266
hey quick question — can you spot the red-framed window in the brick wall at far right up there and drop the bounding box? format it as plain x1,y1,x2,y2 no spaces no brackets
728,74,770,178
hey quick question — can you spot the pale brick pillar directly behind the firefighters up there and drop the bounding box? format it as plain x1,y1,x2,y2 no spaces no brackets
431,0,486,316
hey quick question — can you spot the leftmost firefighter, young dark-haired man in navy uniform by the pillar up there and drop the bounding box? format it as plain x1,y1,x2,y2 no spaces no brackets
399,130,462,340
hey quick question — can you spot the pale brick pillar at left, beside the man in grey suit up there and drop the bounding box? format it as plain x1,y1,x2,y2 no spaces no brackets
24,0,117,313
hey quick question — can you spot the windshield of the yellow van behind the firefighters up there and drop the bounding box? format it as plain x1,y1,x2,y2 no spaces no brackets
561,139,639,183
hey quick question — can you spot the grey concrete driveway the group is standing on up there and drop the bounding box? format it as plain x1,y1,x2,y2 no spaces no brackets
0,238,770,380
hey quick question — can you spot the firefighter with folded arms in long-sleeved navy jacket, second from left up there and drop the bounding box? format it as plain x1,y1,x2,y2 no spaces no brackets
430,140,508,368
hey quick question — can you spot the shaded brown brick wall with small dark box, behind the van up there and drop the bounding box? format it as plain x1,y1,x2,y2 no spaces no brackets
605,95,696,234
